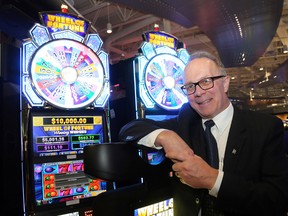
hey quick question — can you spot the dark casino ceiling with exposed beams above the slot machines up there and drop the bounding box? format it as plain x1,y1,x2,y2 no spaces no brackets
0,0,288,113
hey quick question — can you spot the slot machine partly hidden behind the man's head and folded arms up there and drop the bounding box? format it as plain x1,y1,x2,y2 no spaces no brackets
133,30,190,216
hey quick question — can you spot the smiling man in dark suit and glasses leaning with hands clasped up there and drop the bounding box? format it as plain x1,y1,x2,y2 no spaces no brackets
119,51,288,216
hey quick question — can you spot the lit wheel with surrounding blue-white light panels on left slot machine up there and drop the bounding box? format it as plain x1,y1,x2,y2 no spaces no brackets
22,24,110,110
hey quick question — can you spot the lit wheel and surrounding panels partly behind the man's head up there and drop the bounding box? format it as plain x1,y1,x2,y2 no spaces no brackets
137,42,189,110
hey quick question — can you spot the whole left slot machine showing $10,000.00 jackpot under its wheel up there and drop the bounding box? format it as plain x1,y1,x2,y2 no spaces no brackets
21,7,110,216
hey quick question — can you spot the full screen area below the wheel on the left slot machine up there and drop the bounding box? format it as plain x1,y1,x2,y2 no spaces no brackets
29,110,107,208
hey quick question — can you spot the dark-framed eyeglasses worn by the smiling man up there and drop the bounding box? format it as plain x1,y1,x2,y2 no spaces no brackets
181,75,225,95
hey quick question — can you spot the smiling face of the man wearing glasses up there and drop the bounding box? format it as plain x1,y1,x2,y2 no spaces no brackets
184,58,230,118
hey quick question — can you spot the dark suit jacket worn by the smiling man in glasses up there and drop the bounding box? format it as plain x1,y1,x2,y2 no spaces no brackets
119,103,288,216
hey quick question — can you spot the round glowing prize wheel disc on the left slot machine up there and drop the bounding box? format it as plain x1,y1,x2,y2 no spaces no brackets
29,39,104,109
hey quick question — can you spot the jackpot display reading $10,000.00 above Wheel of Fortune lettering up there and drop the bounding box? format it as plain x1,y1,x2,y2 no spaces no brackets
32,115,104,157
